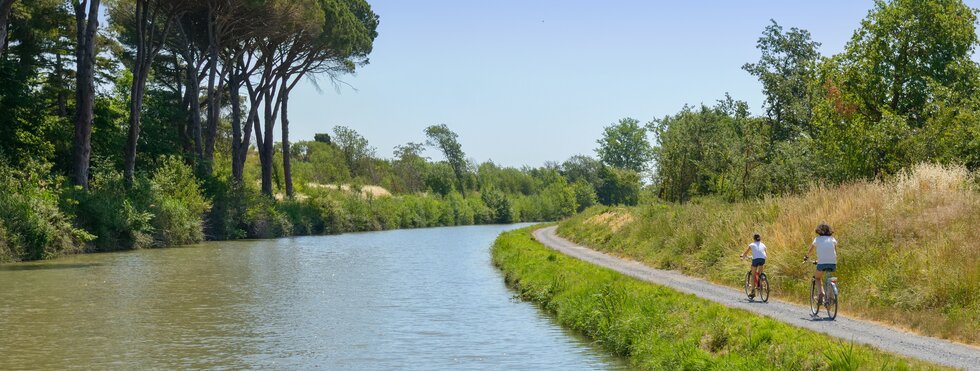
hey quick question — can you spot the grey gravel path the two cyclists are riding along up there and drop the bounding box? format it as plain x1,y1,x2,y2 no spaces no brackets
534,227,980,370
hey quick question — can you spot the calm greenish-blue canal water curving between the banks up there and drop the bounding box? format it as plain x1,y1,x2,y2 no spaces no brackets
0,226,623,370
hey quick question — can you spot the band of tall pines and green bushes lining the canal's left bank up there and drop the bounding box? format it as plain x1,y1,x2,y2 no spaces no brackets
0,0,639,262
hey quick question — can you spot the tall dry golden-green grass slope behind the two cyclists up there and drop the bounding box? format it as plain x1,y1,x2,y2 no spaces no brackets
559,165,980,345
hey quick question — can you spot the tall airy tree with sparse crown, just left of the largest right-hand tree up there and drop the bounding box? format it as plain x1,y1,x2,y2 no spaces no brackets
742,20,820,142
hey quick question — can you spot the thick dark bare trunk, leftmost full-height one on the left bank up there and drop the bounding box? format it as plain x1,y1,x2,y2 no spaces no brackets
72,0,100,191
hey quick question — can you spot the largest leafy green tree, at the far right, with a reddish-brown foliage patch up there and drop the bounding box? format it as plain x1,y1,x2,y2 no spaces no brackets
813,0,980,181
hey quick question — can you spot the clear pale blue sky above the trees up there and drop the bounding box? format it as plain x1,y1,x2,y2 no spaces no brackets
284,0,980,166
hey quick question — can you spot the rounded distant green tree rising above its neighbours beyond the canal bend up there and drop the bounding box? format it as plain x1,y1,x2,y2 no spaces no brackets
596,117,652,172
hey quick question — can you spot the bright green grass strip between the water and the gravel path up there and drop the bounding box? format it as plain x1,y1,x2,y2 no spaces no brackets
493,227,938,370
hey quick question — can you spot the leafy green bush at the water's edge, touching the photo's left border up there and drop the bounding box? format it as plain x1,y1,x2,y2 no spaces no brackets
0,161,92,262
